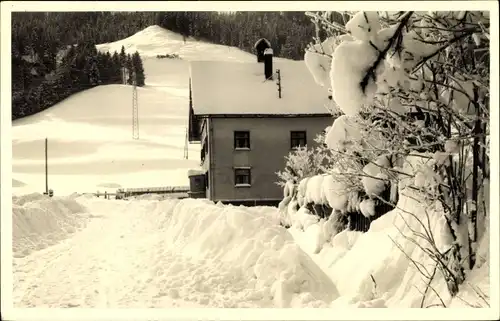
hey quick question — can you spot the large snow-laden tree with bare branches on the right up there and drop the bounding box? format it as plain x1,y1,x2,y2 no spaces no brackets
305,11,490,296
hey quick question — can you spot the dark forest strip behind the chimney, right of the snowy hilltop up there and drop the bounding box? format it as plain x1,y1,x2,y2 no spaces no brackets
155,11,322,60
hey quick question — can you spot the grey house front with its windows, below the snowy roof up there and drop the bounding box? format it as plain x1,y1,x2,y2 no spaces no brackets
195,115,332,204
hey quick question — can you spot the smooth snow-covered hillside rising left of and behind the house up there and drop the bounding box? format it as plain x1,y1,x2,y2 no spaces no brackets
12,26,268,195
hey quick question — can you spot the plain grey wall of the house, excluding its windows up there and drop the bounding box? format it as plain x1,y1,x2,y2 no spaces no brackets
209,116,333,201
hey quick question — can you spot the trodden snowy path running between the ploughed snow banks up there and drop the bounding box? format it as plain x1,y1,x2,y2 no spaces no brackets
13,200,272,308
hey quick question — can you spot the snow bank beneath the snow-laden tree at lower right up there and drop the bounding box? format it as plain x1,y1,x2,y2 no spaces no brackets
289,182,489,308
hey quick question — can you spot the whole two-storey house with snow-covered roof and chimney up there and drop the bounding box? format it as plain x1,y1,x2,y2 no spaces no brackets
189,48,333,205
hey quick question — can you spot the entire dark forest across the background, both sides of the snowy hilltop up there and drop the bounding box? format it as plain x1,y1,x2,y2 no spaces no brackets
12,12,326,119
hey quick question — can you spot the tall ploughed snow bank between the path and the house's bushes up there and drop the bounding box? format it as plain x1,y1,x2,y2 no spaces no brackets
165,199,337,307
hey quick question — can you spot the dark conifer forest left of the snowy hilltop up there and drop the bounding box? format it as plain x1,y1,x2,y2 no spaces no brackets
12,13,149,120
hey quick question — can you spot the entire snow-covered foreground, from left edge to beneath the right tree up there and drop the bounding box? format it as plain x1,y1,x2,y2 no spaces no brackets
9,190,491,309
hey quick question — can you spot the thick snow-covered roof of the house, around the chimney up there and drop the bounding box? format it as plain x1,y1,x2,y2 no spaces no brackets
190,59,333,115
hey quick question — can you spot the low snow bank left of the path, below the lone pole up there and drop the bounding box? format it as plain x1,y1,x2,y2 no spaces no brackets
12,193,88,257
